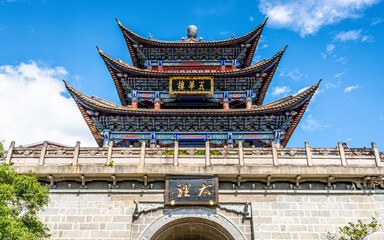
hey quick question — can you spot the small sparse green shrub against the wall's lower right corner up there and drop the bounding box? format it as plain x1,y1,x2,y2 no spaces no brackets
327,218,381,240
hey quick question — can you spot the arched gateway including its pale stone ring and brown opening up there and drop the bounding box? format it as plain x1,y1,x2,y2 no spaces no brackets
139,207,246,240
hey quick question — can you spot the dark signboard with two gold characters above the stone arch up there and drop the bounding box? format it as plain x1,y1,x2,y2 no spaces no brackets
165,176,218,205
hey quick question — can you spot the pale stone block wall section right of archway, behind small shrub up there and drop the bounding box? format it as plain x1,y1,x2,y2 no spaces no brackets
252,194,384,240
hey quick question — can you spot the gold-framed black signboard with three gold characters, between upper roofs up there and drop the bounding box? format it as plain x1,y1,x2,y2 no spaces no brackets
169,77,213,94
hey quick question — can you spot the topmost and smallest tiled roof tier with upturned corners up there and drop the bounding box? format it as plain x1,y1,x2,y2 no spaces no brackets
116,18,268,67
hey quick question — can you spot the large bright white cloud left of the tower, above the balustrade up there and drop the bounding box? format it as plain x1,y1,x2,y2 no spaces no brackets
0,62,96,147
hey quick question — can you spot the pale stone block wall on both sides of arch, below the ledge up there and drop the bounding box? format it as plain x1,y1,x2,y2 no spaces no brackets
40,191,384,240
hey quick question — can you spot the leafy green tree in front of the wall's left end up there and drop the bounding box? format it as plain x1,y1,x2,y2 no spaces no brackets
0,163,50,240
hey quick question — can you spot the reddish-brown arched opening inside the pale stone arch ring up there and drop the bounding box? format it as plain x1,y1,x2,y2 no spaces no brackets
151,218,234,240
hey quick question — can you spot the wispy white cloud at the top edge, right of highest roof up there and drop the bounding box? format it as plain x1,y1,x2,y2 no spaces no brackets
259,0,379,37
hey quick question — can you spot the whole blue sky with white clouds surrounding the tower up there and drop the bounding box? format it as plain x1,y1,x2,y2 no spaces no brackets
0,0,384,150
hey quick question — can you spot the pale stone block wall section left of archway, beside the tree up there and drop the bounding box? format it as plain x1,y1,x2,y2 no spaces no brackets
40,193,134,240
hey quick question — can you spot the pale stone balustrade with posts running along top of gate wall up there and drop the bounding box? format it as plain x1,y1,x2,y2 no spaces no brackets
0,142,384,167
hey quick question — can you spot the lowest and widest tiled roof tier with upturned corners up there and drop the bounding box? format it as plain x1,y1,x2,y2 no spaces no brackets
65,80,321,147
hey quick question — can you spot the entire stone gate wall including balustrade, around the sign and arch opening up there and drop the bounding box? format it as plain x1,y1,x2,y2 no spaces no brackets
0,142,384,240
